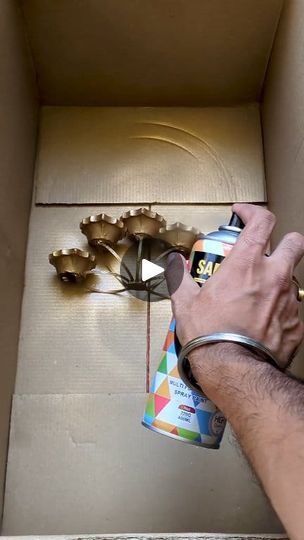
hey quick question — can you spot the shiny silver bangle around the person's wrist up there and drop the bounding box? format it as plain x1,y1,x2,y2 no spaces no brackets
178,332,280,392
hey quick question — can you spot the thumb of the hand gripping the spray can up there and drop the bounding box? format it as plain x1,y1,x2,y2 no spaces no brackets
165,252,200,303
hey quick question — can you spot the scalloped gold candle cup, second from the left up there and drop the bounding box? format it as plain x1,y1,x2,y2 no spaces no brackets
80,214,125,246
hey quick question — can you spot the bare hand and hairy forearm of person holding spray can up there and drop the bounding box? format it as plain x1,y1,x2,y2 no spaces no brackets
166,204,304,540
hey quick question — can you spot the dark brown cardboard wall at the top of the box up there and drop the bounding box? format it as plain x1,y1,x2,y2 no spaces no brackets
22,0,282,106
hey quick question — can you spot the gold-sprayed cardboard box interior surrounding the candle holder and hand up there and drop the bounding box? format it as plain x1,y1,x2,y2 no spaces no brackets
0,0,304,534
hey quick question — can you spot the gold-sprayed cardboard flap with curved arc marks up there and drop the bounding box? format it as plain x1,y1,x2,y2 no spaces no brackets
36,104,265,204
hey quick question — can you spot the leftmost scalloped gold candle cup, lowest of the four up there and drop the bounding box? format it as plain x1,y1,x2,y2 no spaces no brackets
49,248,96,283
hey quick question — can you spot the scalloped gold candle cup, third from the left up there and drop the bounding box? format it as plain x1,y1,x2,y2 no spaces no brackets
120,208,166,237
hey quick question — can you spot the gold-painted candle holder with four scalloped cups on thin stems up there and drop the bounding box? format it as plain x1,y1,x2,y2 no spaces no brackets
49,208,199,299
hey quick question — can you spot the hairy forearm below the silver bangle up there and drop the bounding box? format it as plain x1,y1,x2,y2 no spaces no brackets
190,344,304,540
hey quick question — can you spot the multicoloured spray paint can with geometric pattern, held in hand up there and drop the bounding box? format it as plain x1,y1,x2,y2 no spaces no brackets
142,214,244,449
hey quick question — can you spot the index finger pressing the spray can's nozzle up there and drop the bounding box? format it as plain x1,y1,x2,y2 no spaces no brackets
232,203,276,255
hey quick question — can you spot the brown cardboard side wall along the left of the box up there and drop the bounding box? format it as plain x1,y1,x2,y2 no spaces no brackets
0,0,37,516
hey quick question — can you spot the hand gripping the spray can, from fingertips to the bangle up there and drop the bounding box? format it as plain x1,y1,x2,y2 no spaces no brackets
166,204,304,368
